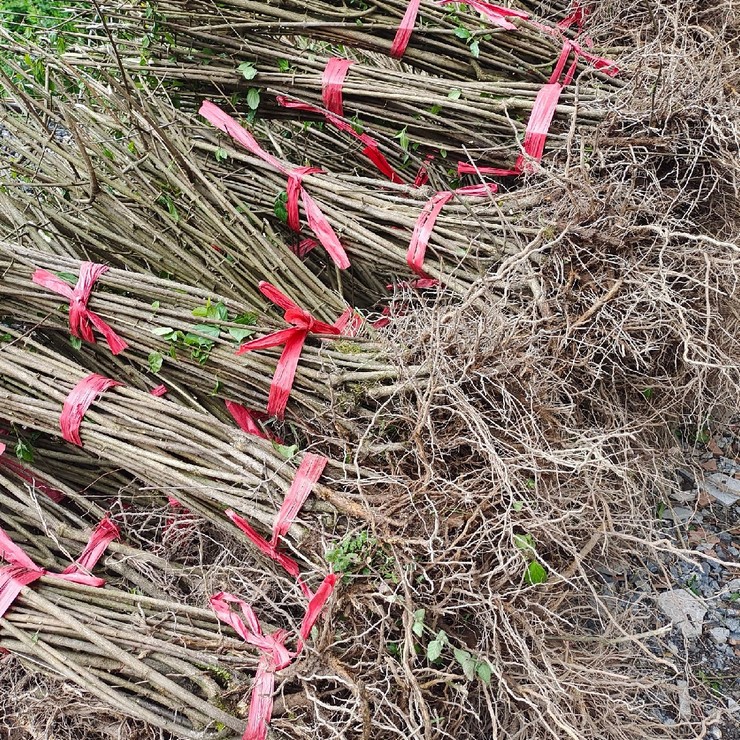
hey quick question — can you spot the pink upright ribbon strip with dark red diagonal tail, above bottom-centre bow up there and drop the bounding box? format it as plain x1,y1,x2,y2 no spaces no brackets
225,452,327,599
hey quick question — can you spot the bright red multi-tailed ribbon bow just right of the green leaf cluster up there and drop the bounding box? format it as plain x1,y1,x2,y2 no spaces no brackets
236,280,341,419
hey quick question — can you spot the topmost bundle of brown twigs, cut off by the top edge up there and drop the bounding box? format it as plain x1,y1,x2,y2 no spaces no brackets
146,0,620,81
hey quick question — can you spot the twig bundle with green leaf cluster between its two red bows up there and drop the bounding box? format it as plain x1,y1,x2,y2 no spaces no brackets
0,243,420,427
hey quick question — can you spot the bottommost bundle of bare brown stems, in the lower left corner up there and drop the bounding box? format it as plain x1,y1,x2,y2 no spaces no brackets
0,577,256,740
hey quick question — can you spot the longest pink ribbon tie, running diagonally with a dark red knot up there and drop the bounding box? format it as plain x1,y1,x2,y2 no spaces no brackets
199,100,349,270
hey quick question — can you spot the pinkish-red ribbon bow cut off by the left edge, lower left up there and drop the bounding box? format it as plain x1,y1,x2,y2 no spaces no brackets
0,517,118,617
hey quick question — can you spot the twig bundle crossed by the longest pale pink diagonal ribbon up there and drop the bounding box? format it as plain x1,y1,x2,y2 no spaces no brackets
195,105,541,296
